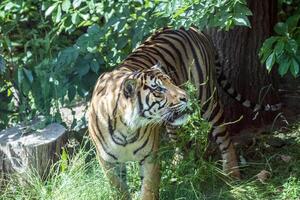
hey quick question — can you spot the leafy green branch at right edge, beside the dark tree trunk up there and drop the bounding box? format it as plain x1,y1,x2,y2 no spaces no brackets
259,0,300,77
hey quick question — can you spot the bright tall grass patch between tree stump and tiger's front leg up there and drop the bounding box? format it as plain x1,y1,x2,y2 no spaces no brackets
0,141,114,200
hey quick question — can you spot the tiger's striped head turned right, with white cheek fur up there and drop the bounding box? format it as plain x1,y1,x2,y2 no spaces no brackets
123,63,188,126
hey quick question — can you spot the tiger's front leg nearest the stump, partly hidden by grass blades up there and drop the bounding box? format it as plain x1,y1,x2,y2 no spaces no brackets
99,157,131,200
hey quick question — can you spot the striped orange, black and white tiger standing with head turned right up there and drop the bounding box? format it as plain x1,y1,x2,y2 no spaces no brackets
88,27,280,200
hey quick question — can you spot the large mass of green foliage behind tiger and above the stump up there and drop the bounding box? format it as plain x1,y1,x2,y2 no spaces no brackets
0,0,251,129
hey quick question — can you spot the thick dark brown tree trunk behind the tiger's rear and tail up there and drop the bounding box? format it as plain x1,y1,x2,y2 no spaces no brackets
209,0,279,133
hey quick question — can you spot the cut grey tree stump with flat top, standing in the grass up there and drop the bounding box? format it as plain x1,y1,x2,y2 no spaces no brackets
0,120,66,186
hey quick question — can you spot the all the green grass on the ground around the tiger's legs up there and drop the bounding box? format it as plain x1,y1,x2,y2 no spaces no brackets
0,126,300,200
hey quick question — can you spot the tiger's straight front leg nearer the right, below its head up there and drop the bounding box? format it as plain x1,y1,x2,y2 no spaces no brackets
141,159,160,200
